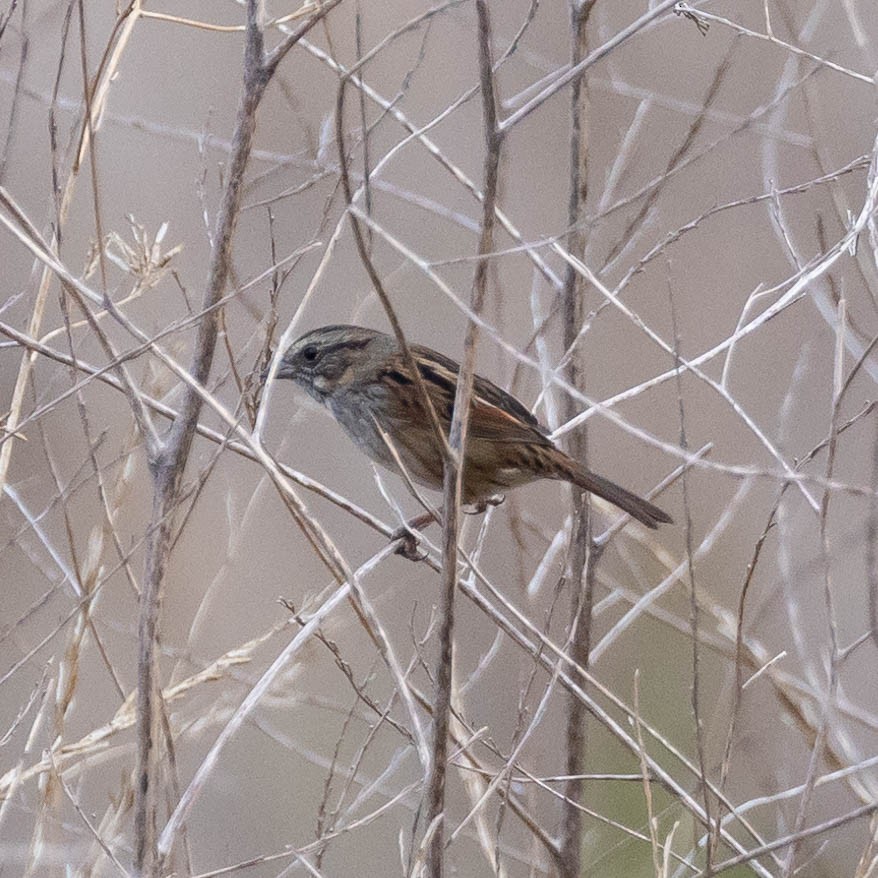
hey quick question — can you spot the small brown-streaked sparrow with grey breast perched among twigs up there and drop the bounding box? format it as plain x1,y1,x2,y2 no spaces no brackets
268,326,671,528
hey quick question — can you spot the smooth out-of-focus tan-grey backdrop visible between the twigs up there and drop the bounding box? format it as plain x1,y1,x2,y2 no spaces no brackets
0,0,878,876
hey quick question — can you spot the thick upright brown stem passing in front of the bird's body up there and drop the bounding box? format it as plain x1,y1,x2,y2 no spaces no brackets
426,0,502,878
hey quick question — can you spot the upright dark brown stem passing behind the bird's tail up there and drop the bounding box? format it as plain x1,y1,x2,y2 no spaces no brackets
558,0,598,878
